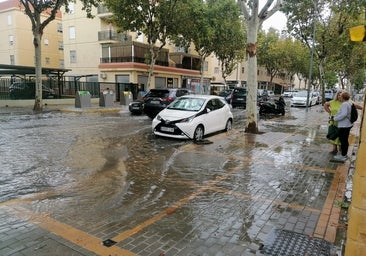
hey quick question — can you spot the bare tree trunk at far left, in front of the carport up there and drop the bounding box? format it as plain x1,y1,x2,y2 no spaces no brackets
33,26,43,112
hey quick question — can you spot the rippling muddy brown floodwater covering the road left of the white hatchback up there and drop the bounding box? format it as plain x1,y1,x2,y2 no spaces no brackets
0,112,184,217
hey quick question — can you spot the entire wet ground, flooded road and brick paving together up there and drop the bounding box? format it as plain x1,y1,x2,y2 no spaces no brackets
0,102,358,256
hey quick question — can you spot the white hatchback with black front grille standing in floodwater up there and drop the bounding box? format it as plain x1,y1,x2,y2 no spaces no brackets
152,95,233,141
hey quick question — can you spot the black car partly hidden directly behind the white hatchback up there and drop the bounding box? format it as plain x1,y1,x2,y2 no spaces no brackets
143,88,192,119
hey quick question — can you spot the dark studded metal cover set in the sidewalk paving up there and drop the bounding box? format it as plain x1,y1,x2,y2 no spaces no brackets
262,229,332,256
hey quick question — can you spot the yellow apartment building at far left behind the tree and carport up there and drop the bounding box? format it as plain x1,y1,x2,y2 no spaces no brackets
0,0,64,68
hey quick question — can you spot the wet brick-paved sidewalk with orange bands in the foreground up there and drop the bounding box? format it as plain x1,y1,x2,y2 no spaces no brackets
0,103,359,256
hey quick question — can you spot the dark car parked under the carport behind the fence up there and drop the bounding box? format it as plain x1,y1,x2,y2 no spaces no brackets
9,82,55,100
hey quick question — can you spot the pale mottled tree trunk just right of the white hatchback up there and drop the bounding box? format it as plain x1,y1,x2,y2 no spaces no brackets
245,17,258,133
